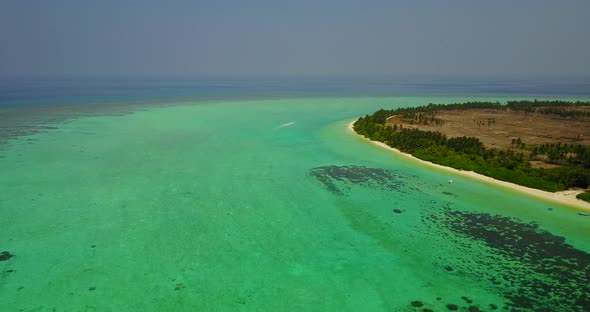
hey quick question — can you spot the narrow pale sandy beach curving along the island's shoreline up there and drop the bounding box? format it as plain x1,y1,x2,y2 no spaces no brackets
347,120,590,212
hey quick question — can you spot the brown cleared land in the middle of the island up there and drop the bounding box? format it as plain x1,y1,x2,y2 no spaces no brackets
387,107,590,153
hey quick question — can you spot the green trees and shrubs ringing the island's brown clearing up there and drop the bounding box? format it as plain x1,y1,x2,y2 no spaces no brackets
354,101,590,192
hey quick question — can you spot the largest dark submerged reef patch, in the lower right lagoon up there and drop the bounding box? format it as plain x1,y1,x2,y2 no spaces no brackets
423,207,590,311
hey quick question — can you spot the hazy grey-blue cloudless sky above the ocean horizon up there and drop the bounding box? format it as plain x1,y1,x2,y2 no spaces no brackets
0,0,590,77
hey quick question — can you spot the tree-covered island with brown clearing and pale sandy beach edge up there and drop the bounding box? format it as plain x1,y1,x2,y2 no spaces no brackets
350,100,590,209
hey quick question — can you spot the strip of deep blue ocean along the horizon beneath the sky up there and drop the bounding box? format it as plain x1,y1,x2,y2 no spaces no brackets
0,77,590,108
